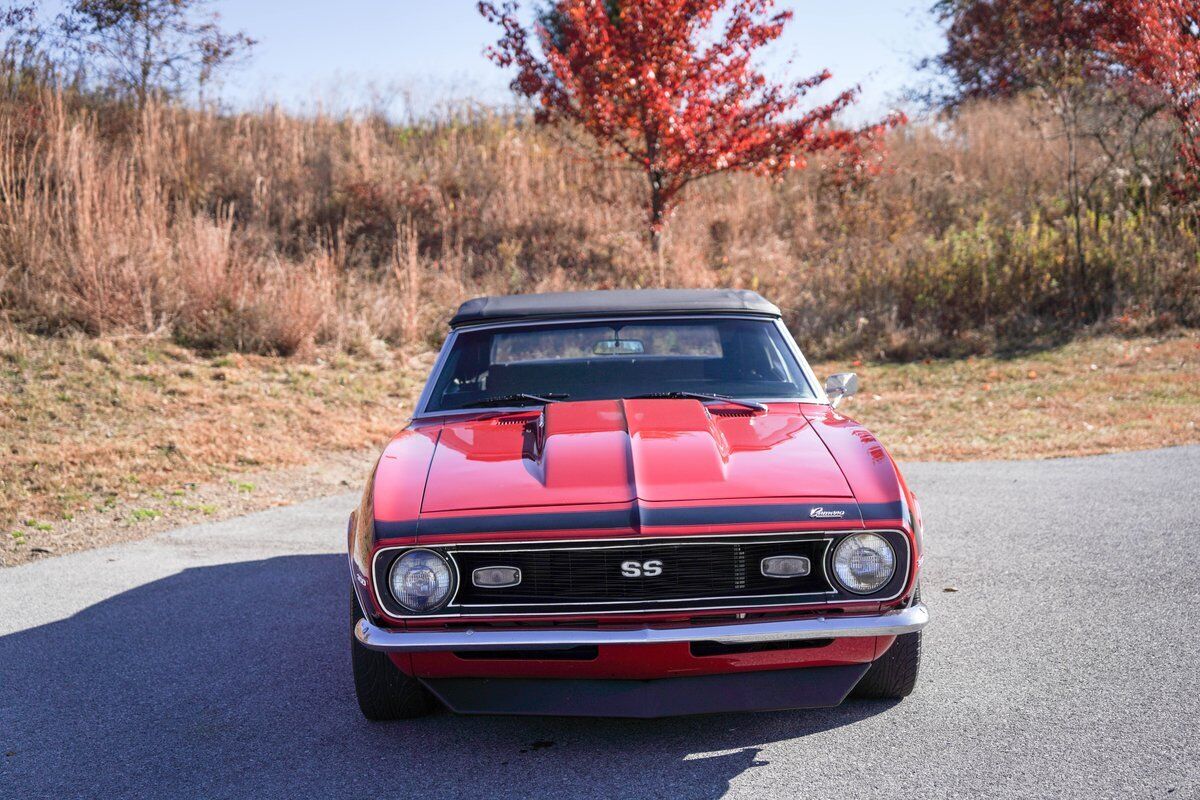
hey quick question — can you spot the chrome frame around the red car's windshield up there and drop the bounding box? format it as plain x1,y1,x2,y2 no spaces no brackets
413,312,829,420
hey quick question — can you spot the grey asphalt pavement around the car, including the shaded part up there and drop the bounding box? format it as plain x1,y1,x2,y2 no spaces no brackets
0,447,1200,800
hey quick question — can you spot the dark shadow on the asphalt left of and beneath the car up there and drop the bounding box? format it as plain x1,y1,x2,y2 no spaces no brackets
0,555,892,800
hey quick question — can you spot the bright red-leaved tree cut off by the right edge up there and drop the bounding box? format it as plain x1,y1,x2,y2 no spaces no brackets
1102,0,1200,191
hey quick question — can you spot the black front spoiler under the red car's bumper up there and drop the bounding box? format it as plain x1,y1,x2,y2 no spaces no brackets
420,663,871,718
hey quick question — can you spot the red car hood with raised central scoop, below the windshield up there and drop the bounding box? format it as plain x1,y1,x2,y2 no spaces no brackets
421,399,853,513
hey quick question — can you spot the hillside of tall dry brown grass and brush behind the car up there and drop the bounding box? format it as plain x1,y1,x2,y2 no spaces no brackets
0,88,1200,359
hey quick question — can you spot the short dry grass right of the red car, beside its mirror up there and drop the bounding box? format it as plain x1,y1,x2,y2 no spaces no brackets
816,333,1200,461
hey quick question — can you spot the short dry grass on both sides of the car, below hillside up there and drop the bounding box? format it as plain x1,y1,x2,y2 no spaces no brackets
0,331,1200,565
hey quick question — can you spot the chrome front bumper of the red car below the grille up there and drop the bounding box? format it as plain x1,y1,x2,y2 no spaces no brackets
354,603,929,652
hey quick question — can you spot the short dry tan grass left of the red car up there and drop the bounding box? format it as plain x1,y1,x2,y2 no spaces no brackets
0,331,431,561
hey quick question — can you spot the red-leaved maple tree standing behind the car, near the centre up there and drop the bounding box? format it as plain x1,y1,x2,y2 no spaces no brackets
479,0,904,252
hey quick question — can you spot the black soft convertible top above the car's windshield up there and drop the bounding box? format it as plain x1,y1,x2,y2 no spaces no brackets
450,289,780,327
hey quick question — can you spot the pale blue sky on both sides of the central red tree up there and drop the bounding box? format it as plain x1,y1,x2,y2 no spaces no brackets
211,0,941,121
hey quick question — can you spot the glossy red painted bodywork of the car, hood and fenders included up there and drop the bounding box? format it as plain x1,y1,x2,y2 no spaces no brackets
349,399,922,679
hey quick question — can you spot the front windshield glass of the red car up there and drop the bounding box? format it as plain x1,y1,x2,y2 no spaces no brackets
425,318,815,411
